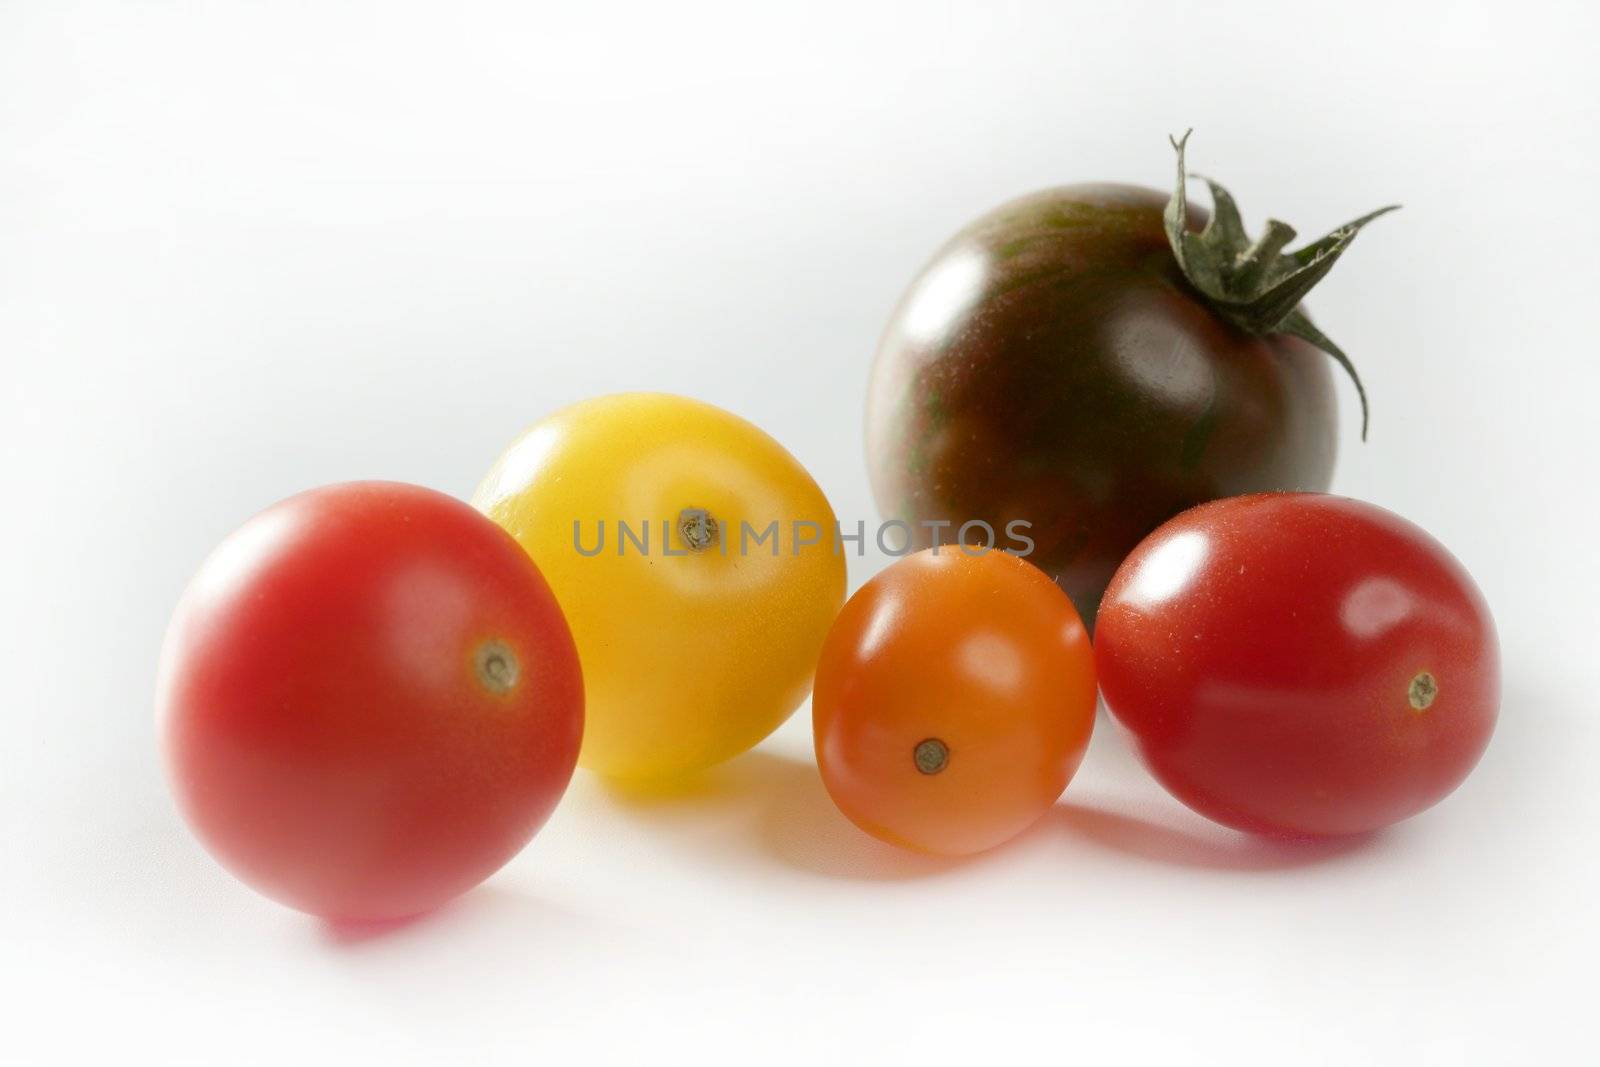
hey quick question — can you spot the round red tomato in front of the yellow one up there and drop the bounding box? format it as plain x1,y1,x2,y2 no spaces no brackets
157,482,582,920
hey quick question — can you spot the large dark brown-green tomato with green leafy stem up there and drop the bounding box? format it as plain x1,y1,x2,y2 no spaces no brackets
867,139,1401,625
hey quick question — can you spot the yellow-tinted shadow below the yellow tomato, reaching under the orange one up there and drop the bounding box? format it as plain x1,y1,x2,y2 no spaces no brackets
605,750,962,881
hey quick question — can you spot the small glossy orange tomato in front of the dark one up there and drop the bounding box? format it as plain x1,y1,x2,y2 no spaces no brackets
811,545,1094,856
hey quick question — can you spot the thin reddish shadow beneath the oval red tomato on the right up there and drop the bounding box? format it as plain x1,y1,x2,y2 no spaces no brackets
1046,801,1381,872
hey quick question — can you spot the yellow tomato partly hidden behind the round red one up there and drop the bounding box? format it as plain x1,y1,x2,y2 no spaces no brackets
472,394,845,779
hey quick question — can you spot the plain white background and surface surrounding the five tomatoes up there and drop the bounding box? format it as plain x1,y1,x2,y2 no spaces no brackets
0,0,1600,1064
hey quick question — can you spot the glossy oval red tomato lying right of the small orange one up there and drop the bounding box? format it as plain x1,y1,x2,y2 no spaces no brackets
1094,493,1499,837
